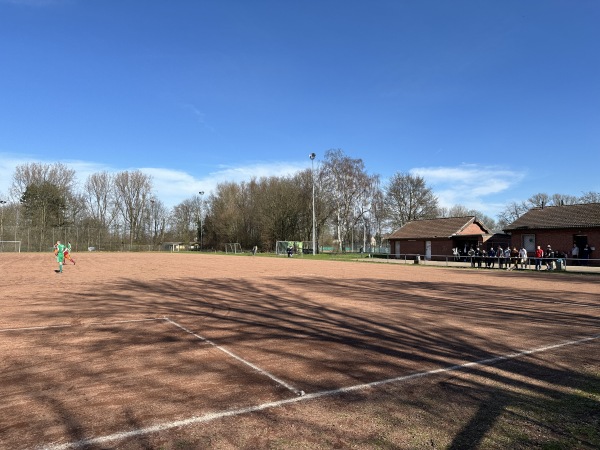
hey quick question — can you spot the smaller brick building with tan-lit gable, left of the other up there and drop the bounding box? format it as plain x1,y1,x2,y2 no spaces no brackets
388,216,500,259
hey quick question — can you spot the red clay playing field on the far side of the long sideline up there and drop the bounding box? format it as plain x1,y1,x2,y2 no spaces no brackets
0,253,600,448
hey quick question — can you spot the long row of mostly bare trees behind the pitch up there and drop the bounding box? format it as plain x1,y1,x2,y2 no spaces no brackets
0,149,600,251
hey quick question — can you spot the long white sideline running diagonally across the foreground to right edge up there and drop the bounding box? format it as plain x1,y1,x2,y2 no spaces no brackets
41,332,600,450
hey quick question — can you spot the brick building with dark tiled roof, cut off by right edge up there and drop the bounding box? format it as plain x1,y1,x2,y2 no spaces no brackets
504,203,600,259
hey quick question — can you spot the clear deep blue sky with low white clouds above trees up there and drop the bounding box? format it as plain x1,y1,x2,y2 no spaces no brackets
0,0,600,217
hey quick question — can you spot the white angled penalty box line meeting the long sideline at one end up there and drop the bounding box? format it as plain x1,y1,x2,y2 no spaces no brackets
0,317,304,396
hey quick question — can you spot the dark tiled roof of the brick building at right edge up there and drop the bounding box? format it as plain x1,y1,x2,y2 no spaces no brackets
504,203,600,231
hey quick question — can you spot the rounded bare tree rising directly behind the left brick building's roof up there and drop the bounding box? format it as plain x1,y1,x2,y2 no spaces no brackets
385,172,438,228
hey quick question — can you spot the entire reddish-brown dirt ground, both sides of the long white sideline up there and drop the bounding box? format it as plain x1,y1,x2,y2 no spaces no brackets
0,253,600,449
